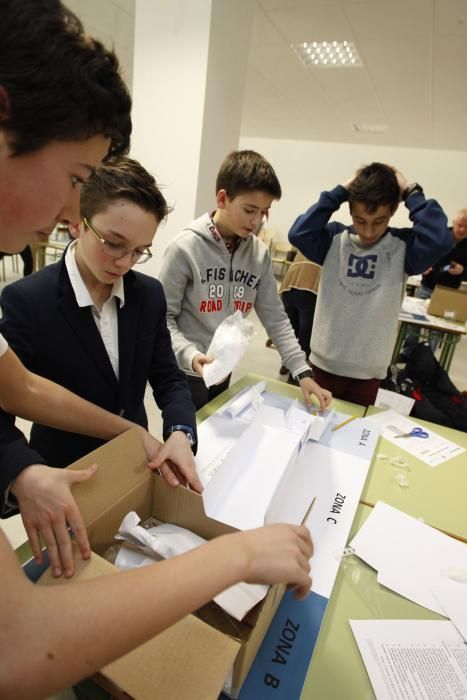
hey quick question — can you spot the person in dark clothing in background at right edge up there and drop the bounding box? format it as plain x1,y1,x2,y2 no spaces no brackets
415,209,467,299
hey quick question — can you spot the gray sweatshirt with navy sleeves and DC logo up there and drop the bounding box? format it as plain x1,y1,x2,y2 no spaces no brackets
289,185,452,379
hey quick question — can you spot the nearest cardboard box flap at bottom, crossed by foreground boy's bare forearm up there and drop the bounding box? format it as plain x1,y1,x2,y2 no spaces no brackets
39,553,240,700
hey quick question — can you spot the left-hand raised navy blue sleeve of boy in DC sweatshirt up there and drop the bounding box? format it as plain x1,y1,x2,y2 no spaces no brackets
289,185,348,265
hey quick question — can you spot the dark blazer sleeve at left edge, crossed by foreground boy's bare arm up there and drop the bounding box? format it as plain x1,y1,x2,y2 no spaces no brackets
0,285,45,517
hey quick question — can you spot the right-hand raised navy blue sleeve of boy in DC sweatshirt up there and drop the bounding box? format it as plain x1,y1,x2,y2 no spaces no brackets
405,192,453,275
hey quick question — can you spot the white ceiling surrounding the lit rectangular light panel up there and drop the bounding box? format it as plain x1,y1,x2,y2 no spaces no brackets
241,0,467,150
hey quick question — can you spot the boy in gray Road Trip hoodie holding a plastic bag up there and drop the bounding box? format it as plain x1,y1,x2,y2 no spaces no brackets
159,151,331,408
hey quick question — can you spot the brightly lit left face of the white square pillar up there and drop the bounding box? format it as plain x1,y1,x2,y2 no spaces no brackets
131,0,211,275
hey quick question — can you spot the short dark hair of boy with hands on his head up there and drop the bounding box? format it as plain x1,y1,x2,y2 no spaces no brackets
348,163,400,214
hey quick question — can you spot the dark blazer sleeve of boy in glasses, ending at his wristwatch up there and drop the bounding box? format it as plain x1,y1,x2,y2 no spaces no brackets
148,285,196,448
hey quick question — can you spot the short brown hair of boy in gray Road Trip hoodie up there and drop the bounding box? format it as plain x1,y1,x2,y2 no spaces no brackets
216,151,282,199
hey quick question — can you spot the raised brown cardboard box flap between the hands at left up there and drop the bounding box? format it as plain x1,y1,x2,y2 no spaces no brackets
67,429,152,525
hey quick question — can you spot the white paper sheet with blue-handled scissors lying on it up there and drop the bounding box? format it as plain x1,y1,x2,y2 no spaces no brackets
366,410,465,467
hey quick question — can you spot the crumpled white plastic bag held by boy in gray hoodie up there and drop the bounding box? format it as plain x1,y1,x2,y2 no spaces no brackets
203,311,253,387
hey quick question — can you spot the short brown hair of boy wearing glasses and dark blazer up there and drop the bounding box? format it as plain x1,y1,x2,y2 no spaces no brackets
80,156,172,223
